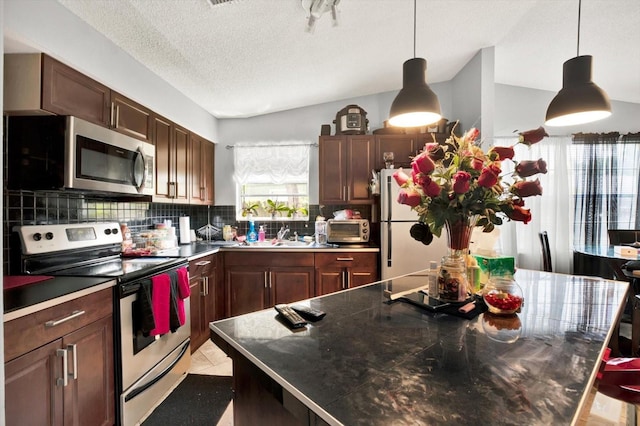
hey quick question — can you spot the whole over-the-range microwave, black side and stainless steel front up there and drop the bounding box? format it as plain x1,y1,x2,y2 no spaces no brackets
6,116,155,195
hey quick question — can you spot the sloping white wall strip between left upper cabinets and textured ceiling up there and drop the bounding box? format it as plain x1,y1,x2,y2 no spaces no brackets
2,0,217,141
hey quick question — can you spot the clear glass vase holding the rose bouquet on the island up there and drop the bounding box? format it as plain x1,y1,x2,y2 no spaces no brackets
438,217,475,302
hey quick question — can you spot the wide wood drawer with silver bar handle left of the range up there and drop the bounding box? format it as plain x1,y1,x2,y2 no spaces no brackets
4,288,113,361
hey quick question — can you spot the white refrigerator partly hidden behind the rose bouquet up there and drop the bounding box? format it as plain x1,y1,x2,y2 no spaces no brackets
380,169,447,280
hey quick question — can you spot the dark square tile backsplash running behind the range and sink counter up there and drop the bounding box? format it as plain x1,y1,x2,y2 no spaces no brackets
3,190,371,275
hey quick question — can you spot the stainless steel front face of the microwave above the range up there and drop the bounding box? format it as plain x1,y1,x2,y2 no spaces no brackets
65,117,155,195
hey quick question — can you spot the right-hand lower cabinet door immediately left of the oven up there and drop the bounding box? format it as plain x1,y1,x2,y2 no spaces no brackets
62,316,115,426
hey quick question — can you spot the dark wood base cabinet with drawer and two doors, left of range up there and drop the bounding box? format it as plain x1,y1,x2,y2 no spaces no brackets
4,288,115,426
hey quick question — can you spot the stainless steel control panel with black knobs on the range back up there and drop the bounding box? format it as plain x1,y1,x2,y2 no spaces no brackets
13,222,122,255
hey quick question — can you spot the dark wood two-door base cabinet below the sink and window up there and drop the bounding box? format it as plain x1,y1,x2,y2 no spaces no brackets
224,251,314,317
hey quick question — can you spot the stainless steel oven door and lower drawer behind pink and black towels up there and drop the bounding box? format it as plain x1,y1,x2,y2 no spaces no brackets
119,282,191,425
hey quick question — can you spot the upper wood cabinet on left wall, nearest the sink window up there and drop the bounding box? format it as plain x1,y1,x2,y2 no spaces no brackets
190,133,215,205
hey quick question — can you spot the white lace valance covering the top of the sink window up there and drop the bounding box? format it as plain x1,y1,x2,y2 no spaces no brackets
233,141,311,185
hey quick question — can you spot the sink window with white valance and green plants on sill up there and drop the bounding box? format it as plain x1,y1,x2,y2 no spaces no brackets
234,142,311,221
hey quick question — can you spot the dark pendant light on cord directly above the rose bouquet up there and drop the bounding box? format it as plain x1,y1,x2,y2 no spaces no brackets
389,0,442,127
